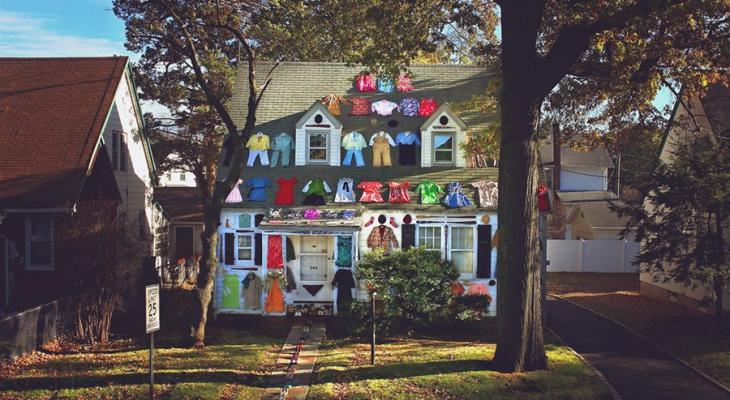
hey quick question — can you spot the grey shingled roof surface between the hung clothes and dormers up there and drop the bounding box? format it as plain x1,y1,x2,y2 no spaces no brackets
222,62,497,210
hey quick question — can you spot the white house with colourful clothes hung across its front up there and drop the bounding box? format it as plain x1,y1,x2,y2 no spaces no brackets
193,62,497,315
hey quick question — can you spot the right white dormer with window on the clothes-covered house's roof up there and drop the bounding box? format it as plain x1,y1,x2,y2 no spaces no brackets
421,103,467,167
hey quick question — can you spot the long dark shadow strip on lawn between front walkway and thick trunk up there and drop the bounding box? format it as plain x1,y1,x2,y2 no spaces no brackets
312,360,496,384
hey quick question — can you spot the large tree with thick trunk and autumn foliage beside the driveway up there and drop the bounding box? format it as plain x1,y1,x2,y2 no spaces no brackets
494,0,730,371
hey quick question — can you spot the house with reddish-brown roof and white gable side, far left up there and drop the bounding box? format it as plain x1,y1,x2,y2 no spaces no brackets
0,57,156,310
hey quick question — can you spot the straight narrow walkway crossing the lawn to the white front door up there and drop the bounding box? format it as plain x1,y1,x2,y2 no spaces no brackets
263,323,325,400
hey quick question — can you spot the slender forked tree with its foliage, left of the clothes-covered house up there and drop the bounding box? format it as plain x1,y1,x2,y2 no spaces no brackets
114,0,272,347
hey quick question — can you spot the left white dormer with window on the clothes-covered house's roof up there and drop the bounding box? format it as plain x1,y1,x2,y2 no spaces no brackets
294,101,342,166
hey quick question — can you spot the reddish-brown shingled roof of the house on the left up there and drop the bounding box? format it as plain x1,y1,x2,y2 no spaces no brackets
0,57,127,208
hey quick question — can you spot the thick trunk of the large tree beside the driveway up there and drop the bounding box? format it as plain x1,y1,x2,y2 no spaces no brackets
494,1,547,372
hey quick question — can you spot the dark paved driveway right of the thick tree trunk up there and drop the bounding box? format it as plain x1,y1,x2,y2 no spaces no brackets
547,297,730,400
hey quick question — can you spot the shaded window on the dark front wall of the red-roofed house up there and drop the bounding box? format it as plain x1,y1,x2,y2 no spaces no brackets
25,216,53,270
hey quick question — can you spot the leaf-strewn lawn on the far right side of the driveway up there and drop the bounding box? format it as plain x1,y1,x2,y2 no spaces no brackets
547,273,730,386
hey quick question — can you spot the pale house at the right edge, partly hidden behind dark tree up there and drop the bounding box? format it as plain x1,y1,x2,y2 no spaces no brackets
641,85,730,312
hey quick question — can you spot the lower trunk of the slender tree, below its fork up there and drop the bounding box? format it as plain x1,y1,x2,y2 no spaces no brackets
193,205,221,348
